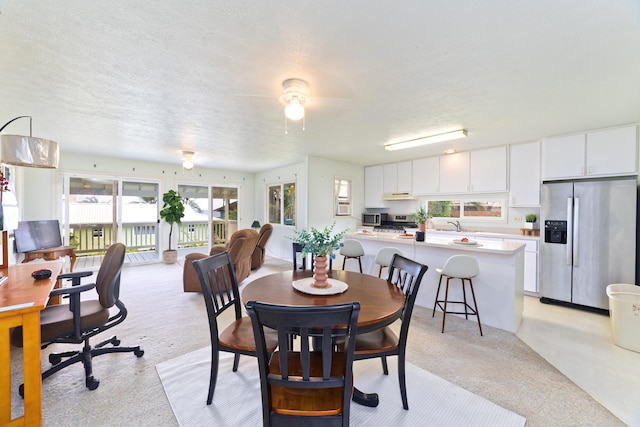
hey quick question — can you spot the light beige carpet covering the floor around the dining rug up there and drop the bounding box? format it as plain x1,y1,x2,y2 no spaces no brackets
6,257,624,427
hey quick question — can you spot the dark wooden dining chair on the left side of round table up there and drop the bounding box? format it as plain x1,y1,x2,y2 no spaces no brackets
193,252,278,405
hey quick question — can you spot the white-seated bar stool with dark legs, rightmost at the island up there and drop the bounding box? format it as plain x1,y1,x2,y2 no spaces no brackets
431,255,482,336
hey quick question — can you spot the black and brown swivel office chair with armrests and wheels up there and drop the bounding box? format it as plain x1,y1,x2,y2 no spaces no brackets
11,243,144,397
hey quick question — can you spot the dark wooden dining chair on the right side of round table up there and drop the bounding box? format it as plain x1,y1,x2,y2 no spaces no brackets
336,254,428,409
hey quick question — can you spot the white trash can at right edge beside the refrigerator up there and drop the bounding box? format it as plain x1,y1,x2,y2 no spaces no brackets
607,283,640,353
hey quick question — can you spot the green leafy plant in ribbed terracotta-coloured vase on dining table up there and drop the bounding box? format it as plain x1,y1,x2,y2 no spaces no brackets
289,222,348,288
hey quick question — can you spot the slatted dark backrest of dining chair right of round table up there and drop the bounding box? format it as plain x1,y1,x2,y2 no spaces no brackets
387,254,429,348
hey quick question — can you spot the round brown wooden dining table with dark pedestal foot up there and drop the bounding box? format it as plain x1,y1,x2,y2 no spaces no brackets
242,270,404,406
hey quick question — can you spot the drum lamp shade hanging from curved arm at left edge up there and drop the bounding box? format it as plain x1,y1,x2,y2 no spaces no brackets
0,135,58,169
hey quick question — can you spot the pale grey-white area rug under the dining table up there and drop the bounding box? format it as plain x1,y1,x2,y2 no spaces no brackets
156,347,526,427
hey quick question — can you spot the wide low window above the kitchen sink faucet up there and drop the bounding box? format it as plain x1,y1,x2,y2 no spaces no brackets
427,198,506,221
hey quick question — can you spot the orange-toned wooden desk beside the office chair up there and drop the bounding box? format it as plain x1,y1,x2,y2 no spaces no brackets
0,261,63,426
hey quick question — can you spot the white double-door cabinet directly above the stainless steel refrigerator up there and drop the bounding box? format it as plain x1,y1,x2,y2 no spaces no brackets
542,125,638,180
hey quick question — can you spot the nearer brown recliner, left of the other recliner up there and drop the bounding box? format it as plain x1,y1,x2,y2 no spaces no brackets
182,228,260,292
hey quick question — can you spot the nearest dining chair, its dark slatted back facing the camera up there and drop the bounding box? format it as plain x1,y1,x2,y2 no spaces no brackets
247,301,360,426
